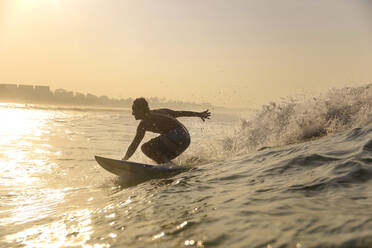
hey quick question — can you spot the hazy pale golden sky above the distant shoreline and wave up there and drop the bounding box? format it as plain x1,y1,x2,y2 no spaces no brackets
0,0,372,107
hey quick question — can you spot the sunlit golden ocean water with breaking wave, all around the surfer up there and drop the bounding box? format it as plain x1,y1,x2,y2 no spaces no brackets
0,85,372,248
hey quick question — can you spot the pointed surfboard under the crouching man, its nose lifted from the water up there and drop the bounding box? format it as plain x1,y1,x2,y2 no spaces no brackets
94,156,187,180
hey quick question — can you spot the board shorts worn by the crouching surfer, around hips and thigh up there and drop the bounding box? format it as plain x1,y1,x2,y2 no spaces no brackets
145,128,190,160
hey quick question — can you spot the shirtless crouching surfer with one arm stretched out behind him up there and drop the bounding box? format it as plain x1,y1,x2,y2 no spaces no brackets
122,98,211,164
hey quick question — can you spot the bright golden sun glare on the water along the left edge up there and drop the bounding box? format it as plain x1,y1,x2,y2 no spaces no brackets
0,105,107,248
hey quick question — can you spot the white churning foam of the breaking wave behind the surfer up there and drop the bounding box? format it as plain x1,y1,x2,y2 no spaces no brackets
187,84,372,162
